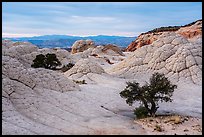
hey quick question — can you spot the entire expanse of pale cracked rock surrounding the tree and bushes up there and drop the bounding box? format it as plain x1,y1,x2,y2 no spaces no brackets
2,19,202,135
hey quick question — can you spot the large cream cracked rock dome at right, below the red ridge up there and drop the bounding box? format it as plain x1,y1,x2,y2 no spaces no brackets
109,32,202,84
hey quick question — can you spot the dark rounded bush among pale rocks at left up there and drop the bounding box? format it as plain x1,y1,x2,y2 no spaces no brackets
31,53,61,70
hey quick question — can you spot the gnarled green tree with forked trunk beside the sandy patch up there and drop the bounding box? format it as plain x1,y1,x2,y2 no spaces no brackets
120,73,177,116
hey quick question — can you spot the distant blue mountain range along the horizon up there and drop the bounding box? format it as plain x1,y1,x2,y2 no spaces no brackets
3,35,136,48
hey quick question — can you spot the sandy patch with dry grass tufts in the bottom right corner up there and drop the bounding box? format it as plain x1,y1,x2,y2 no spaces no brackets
134,115,202,135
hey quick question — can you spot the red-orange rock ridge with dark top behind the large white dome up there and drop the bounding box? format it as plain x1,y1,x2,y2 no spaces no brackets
126,20,202,51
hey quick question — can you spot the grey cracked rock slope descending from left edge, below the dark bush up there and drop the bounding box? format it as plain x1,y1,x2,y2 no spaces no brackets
2,56,79,92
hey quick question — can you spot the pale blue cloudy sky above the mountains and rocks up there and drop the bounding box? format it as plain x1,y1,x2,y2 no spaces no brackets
2,2,202,37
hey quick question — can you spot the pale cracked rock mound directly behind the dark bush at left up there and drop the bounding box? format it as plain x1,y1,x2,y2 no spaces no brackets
2,41,72,67
